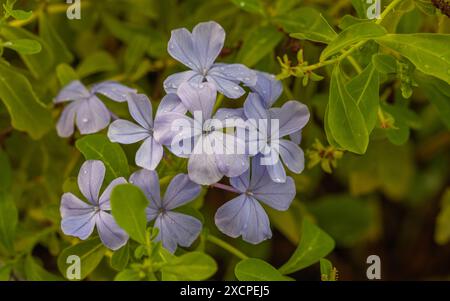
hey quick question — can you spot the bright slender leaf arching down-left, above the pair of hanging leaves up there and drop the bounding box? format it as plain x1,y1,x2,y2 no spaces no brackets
320,23,387,61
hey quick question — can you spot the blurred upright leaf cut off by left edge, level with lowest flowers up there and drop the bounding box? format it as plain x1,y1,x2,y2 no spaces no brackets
0,191,19,254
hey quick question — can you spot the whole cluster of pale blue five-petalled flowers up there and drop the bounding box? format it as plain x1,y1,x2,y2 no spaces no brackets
55,22,309,252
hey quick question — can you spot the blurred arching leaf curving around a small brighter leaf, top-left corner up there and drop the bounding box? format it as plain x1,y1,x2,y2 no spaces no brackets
0,26,55,78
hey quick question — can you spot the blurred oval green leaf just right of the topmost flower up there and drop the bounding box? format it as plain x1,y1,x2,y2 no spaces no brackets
237,26,283,67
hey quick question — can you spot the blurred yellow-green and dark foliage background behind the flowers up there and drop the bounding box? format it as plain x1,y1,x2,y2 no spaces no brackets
0,0,450,280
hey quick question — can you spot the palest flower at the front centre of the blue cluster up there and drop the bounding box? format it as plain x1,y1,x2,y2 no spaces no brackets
155,83,249,185
